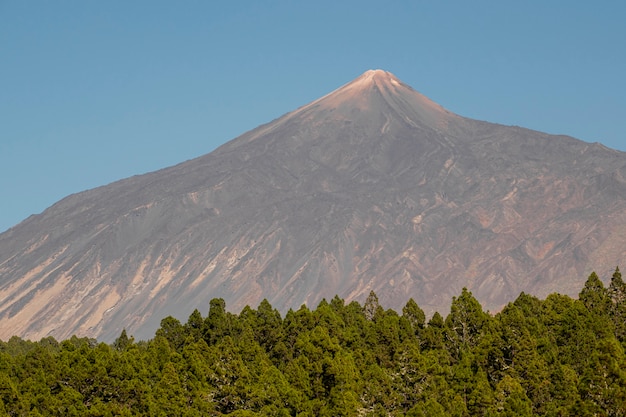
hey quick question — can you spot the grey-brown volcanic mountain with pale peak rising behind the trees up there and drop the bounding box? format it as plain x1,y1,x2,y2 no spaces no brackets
0,70,626,341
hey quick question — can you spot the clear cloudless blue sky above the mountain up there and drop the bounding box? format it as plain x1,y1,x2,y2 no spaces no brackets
0,0,626,231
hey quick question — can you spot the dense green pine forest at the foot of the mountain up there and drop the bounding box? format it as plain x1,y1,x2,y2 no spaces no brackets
0,268,626,417
